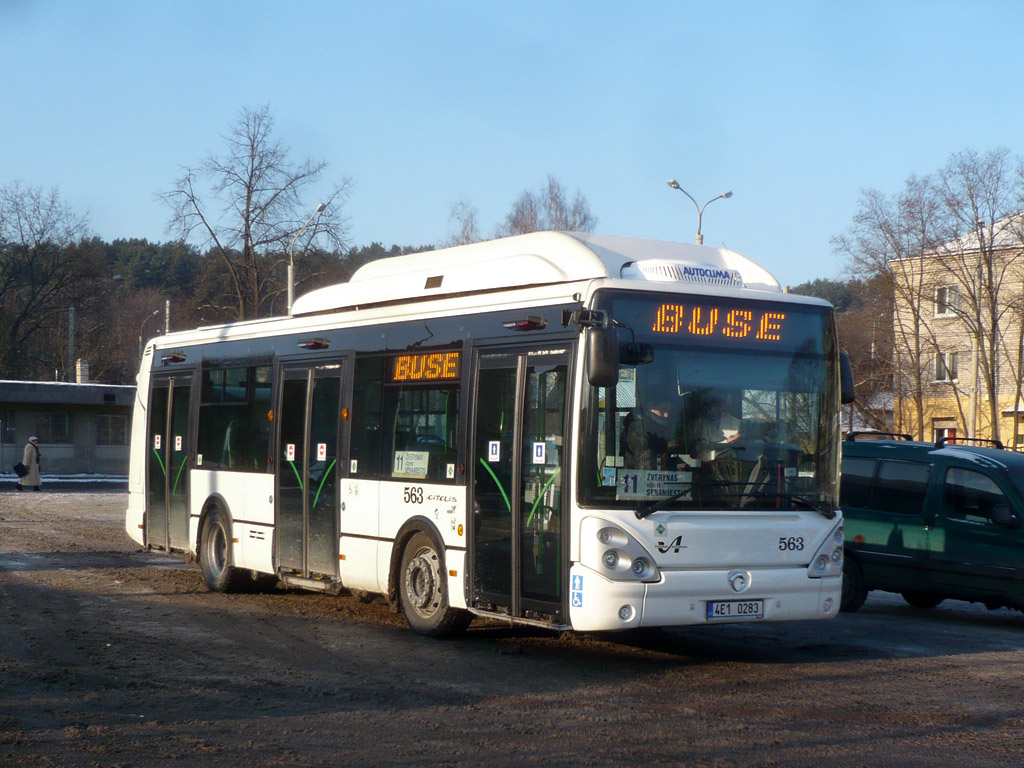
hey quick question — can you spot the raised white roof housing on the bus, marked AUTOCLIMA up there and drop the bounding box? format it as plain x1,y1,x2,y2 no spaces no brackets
292,231,781,315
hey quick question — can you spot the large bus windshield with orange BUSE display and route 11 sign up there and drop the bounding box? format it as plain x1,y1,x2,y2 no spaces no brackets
579,291,840,515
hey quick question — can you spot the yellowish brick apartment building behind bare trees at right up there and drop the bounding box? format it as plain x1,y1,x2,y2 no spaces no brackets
889,216,1024,449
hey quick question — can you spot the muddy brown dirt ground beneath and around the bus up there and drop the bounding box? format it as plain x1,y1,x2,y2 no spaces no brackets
0,490,1024,768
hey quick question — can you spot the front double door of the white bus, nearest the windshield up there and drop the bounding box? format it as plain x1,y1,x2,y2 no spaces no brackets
469,347,569,622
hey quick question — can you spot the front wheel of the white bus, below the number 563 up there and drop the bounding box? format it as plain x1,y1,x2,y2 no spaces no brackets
398,530,472,637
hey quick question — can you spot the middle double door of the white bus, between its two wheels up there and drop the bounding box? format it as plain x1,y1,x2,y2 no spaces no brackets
275,364,342,579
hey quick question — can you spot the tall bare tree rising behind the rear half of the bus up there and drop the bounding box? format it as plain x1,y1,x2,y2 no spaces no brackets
161,106,351,319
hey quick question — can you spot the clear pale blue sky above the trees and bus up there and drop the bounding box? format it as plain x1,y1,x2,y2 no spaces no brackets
0,0,1024,285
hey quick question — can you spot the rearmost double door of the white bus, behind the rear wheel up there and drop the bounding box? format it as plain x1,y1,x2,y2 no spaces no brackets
145,373,191,551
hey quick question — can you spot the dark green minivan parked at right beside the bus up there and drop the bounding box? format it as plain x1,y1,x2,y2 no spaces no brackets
840,432,1024,610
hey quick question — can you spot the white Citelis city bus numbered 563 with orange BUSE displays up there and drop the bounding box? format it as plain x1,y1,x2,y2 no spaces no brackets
126,232,848,636
